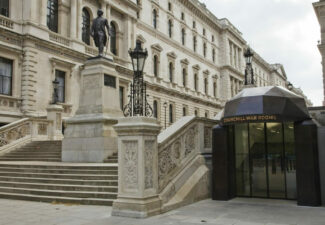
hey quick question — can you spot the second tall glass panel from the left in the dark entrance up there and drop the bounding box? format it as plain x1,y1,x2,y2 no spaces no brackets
249,123,267,197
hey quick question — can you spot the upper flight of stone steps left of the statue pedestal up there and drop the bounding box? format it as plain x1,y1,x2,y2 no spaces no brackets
0,141,62,162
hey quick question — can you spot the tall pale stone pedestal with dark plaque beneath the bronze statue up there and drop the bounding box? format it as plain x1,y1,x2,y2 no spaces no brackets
62,57,123,162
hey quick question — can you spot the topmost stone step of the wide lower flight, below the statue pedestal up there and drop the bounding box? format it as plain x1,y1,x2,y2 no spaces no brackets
0,162,118,170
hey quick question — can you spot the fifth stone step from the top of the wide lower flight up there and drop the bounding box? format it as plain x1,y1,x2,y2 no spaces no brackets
0,187,117,199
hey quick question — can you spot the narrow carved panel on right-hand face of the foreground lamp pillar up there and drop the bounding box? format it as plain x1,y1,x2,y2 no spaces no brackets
144,140,155,189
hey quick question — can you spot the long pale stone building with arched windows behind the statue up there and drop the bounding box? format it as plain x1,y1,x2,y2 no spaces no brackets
0,0,288,126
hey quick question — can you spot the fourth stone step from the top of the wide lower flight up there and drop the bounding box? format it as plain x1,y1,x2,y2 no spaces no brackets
0,181,117,193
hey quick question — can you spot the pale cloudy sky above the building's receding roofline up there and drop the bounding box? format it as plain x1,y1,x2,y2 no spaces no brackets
200,0,323,106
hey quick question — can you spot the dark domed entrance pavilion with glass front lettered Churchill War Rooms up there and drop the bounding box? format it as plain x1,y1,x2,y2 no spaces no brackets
212,87,321,206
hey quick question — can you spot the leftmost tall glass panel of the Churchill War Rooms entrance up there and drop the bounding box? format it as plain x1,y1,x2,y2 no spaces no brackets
235,124,250,196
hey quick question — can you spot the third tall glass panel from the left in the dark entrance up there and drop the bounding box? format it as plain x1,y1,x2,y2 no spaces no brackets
266,123,285,198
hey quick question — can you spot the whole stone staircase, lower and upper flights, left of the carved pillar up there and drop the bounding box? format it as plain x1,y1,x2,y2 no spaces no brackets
0,141,118,206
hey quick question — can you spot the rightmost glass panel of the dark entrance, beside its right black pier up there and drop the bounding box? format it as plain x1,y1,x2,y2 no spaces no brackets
284,123,297,199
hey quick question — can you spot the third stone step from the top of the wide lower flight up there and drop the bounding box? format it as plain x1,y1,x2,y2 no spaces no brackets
0,176,118,186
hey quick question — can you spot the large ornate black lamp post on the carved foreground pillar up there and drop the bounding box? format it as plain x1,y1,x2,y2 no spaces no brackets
123,42,153,117
